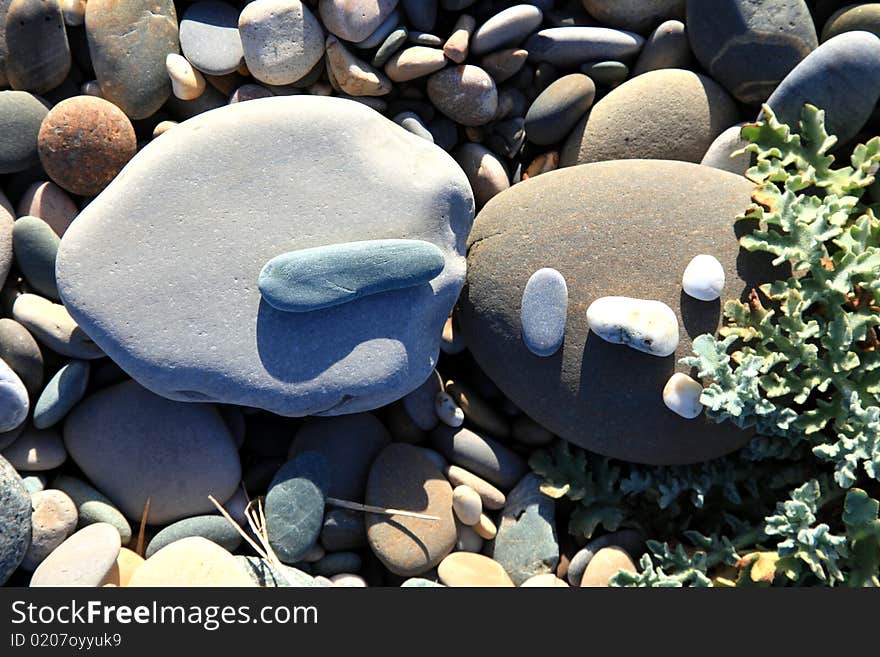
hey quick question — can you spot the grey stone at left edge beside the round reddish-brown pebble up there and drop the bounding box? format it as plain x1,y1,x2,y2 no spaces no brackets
0,91,49,173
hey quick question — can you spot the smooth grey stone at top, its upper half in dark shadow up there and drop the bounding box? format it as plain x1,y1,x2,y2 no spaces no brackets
180,0,244,75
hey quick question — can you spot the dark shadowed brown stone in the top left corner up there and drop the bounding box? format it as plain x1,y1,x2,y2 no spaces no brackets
5,0,71,94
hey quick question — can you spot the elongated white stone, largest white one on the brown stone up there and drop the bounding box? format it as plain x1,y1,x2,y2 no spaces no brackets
587,297,678,356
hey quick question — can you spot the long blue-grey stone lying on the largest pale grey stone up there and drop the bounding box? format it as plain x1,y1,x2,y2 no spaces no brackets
259,240,446,313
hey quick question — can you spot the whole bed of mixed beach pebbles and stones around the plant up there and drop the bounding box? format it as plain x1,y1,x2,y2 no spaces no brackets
0,0,880,588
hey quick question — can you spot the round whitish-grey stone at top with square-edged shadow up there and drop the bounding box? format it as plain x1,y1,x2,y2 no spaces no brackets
238,0,324,85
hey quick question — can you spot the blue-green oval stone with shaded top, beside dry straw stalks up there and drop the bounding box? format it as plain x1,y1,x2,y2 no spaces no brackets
266,452,330,564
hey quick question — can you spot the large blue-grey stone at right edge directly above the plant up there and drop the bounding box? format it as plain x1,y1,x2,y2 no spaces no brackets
767,32,880,144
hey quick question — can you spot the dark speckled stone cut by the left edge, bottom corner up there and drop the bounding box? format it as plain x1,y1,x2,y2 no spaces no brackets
0,456,31,586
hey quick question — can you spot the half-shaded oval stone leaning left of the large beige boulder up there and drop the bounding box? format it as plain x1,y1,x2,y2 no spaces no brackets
526,73,596,146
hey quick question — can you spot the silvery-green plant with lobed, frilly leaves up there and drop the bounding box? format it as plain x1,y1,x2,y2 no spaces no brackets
531,105,880,586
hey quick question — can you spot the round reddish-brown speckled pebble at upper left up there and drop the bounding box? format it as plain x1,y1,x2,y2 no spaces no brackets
37,96,137,196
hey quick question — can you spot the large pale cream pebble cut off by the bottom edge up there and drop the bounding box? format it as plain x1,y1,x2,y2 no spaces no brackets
129,530,255,587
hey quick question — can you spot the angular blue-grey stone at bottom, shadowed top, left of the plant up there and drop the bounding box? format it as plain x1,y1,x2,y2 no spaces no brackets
490,472,559,586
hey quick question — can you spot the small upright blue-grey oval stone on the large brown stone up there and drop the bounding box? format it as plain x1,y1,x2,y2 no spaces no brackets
520,267,568,356
